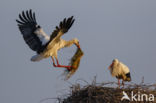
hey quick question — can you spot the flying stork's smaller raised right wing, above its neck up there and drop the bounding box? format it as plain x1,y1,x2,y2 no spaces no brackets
50,16,75,41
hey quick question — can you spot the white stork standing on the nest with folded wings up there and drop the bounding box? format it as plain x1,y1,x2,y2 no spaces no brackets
109,59,131,87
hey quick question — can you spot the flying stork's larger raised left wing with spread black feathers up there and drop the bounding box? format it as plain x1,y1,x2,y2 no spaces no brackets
16,10,47,53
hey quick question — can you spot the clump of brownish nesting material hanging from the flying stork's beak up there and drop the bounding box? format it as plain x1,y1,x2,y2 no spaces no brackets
64,48,83,80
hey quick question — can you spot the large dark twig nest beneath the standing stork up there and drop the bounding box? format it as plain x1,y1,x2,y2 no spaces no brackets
58,78,156,103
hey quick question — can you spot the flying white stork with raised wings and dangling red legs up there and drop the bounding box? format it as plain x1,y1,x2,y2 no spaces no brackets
16,9,80,70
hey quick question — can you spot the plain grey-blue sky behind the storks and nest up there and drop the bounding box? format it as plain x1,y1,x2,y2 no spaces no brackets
0,0,156,103
